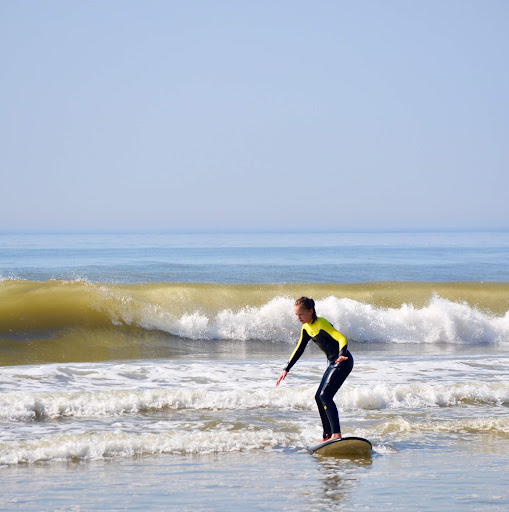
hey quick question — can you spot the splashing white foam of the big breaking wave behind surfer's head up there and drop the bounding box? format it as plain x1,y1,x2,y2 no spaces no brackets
101,295,509,343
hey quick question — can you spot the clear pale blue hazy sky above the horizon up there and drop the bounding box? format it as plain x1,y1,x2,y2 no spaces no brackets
0,0,509,230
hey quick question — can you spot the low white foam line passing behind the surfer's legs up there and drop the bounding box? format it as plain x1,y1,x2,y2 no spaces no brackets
0,382,509,421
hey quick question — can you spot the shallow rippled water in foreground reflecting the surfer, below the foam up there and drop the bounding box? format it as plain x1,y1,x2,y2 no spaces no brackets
0,436,509,512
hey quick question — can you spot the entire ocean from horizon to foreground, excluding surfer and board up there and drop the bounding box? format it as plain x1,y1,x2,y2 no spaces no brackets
0,232,509,512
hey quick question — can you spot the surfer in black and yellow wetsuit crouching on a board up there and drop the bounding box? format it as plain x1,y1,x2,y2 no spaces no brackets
276,297,353,442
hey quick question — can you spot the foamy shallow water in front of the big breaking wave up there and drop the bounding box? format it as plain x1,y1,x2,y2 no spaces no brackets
0,343,509,512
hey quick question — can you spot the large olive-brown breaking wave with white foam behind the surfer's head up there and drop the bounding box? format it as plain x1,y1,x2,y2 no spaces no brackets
0,281,509,343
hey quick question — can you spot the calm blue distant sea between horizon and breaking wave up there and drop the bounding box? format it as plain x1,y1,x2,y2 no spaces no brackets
0,232,509,283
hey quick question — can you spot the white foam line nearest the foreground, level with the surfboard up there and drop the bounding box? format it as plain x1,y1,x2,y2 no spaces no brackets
0,417,509,464
